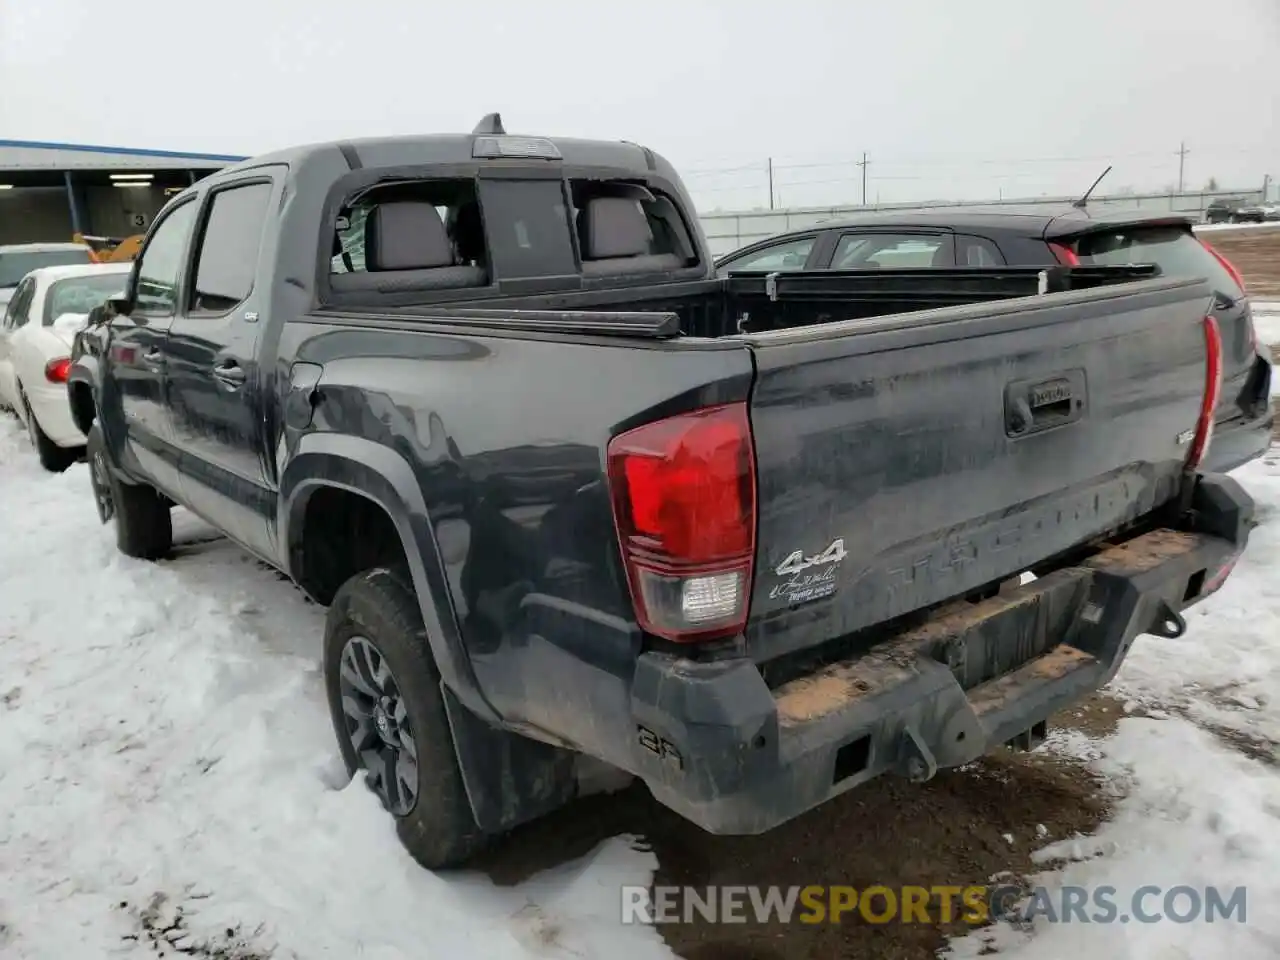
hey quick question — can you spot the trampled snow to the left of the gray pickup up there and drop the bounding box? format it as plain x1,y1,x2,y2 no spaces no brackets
0,416,669,960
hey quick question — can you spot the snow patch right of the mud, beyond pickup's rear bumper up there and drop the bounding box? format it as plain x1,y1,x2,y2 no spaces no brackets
952,454,1280,960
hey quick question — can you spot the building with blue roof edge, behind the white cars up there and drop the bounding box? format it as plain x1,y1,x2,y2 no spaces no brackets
0,140,244,243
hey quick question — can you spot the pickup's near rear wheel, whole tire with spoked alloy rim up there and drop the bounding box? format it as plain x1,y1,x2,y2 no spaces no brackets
324,567,485,870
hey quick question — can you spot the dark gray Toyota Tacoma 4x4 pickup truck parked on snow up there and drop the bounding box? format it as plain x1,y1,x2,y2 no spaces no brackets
69,118,1253,868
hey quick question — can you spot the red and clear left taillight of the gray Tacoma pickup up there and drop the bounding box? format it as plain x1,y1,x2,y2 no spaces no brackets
608,403,755,643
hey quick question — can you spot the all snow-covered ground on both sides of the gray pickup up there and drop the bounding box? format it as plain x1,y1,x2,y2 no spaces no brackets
0,417,1280,960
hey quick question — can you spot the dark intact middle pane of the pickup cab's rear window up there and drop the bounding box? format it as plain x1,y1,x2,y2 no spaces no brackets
480,179,577,280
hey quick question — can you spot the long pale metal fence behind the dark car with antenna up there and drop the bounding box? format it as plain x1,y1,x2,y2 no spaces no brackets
699,189,1262,256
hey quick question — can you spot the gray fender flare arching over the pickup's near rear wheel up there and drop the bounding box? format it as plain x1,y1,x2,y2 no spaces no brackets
276,433,502,724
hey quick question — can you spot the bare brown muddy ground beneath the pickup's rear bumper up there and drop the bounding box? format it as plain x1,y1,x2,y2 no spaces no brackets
483,695,1124,960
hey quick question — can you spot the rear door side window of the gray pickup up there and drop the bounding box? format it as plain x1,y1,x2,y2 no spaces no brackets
189,183,273,314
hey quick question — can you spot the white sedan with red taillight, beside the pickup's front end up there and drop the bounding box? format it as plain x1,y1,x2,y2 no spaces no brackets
0,264,132,471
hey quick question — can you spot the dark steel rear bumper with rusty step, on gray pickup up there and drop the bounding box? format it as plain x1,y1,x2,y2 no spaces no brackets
631,476,1253,833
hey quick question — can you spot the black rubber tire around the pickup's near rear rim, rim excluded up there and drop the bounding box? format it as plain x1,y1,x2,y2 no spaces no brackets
324,567,486,870
